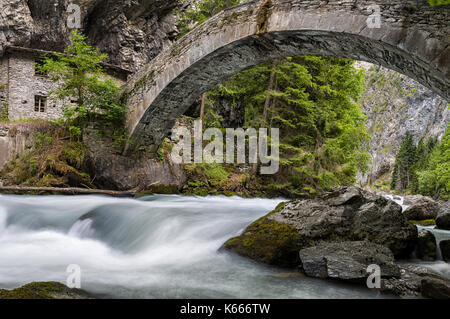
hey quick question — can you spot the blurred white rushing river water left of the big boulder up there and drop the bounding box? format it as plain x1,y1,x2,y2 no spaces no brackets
0,195,386,299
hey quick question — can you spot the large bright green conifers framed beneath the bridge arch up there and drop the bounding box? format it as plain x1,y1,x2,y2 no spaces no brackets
204,57,369,195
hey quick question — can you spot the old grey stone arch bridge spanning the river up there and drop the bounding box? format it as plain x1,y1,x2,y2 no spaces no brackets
124,0,450,152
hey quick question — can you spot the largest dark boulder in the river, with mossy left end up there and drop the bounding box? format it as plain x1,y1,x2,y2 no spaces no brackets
224,186,417,267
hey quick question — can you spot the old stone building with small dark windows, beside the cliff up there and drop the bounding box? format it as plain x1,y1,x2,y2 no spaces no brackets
0,47,131,121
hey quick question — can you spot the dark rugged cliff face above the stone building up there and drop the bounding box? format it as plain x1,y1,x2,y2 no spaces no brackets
0,0,181,71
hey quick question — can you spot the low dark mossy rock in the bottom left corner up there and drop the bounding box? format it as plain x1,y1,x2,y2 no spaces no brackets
0,281,93,299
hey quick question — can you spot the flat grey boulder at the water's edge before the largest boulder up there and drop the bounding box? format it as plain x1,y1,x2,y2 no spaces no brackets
300,241,400,282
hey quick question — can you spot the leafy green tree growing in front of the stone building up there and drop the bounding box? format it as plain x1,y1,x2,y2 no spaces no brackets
36,30,126,135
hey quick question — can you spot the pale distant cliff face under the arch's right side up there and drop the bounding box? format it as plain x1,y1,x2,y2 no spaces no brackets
357,62,450,184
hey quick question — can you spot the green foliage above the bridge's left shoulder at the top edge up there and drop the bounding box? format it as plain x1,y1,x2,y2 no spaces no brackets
177,0,243,38
